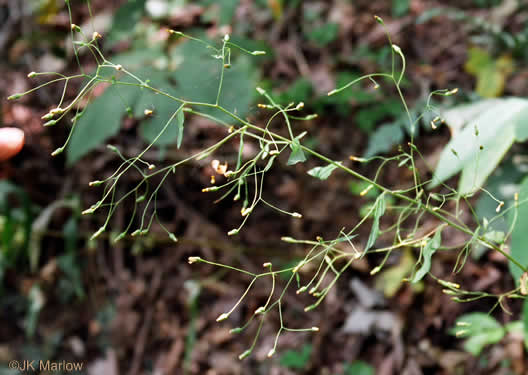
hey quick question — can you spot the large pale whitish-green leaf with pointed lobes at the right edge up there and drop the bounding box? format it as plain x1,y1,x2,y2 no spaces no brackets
430,98,528,194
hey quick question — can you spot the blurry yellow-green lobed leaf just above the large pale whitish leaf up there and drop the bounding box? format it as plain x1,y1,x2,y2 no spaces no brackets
465,47,514,98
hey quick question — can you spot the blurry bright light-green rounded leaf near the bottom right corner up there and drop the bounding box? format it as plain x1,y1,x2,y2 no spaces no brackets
450,312,506,356
